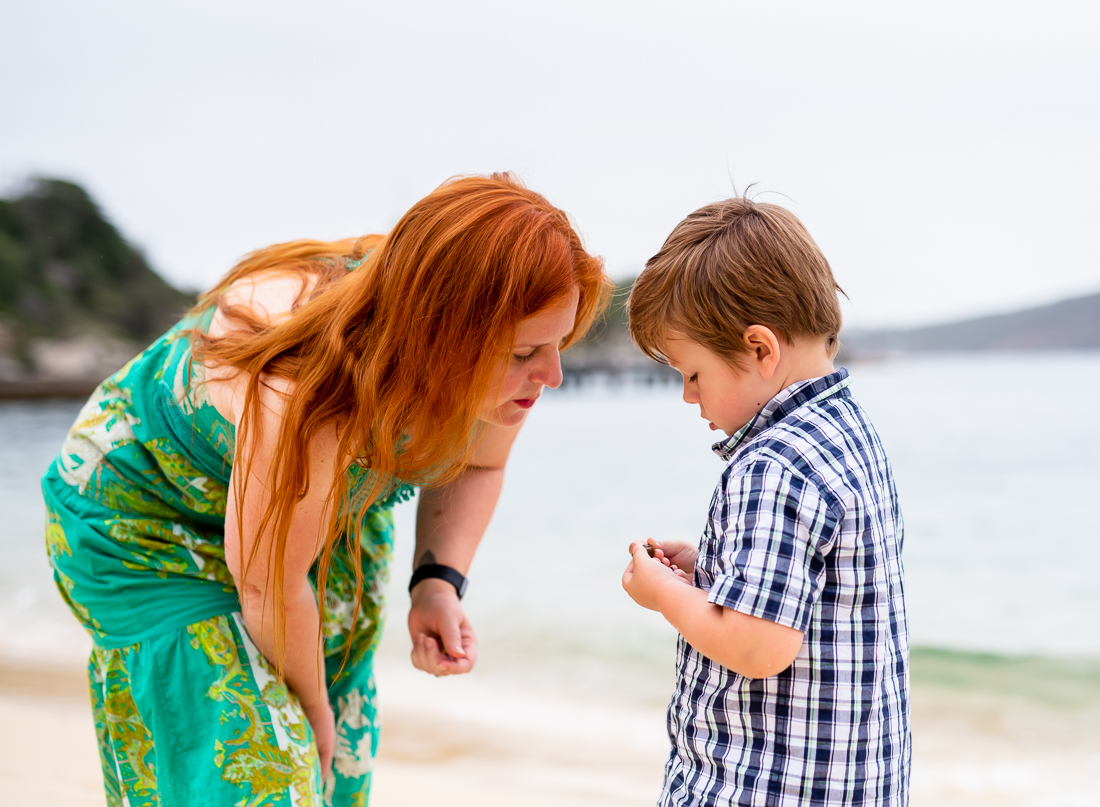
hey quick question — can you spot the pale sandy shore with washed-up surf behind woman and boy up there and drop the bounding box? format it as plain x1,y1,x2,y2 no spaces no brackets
0,651,1100,807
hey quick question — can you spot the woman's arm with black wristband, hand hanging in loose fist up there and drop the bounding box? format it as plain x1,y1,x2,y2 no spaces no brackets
409,423,519,675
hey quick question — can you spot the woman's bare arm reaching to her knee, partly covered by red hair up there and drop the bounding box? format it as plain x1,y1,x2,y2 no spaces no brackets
226,376,337,773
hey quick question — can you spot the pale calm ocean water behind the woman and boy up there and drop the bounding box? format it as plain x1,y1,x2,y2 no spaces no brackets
0,353,1100,690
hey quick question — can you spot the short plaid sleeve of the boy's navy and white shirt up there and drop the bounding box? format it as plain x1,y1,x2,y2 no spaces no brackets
707,460,840,632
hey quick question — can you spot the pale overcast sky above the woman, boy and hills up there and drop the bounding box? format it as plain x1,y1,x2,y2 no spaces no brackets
0,0,1100,328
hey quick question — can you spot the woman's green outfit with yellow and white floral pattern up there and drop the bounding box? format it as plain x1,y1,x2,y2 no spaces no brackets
42,309,413,807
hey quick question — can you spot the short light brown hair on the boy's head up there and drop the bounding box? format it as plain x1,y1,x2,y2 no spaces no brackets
627,197,844,366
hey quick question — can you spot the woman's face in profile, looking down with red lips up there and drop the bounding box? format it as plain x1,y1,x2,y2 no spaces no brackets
481,288,580,427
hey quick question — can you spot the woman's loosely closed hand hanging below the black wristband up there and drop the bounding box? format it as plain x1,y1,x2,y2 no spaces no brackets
409,578,477,676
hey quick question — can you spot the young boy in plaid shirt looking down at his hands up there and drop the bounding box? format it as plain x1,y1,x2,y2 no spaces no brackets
623,199,910,807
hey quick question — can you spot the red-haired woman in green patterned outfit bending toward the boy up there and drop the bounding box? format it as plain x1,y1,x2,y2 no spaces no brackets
43,175,609,807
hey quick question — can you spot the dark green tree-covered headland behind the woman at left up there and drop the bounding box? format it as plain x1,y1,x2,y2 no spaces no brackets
0,179,195,398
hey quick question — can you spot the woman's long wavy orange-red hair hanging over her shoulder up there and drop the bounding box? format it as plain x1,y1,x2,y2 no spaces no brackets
194,174,612,670
